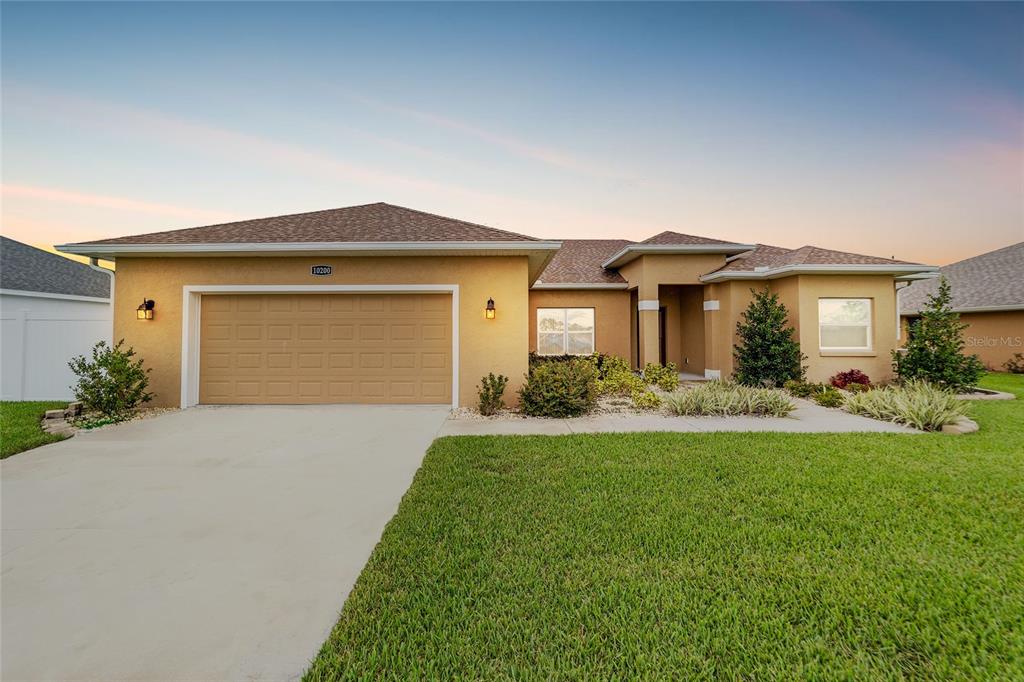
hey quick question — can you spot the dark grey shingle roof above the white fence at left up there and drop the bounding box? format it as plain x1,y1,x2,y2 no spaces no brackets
0,237,111,298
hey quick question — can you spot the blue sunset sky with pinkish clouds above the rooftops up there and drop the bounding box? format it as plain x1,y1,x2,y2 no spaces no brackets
0,2,1024,264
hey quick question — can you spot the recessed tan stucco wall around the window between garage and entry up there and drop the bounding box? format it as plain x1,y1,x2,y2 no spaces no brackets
529,289,630,359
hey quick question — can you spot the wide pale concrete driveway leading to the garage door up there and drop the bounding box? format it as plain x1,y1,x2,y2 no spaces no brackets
0,406,449,680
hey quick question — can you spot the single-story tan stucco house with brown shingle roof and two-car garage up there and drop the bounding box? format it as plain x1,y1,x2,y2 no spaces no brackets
59,199,936,407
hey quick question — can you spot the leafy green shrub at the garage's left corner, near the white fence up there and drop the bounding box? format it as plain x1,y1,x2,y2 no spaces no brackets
68,339,153,421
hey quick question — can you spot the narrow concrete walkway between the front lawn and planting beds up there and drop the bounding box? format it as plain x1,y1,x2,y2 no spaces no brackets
437,398,922,436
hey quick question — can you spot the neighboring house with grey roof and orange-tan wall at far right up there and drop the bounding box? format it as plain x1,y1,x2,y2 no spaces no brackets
899,242,1024,370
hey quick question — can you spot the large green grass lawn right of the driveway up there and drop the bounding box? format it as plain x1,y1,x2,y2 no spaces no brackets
306,375,1024,680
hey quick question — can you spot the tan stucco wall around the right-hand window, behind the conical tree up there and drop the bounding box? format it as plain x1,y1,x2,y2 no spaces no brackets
705,275,897,381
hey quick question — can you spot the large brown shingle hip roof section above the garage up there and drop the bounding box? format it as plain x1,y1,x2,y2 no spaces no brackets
75,203,538,245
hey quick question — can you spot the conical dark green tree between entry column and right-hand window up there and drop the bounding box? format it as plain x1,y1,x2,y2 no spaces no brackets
732,289,806,386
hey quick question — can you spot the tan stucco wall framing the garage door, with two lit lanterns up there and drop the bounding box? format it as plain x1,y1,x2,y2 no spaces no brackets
114,256,529,406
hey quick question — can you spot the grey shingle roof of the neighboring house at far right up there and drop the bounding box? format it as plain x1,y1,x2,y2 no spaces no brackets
899,242,1024,314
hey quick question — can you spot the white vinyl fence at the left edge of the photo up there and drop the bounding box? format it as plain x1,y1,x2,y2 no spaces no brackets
0,290,113,400
